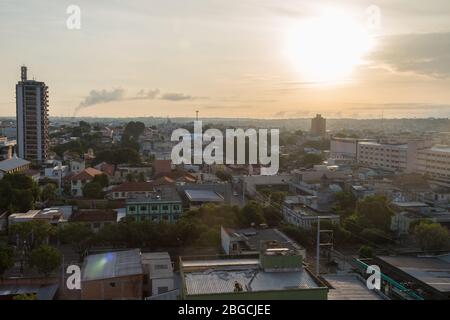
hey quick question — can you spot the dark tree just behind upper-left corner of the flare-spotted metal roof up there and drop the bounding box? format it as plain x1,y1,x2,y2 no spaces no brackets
58,223,94,260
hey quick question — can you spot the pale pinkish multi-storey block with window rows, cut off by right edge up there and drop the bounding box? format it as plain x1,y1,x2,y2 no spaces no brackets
417,146,450,186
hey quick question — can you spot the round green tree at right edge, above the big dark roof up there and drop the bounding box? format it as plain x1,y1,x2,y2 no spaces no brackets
413,222,450,251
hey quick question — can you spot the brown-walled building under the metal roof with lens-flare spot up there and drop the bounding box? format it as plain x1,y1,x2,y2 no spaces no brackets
81,249,144,300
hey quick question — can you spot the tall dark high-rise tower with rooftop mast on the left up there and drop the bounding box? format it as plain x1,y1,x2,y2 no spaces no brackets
16,66,49,162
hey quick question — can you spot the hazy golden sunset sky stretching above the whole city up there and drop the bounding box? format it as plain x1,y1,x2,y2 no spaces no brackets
0,0,450,118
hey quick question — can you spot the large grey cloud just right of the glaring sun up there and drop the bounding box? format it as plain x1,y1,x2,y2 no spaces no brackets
369,33,450,78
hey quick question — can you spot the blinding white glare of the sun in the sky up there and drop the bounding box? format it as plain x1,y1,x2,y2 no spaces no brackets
285,12,374,83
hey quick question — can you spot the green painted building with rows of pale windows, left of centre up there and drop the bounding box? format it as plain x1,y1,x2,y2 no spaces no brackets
126,186,183,223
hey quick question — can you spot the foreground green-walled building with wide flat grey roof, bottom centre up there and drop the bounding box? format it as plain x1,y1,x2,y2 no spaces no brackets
180,246,328,300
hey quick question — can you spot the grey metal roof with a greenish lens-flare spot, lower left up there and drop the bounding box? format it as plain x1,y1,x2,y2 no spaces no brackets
82,249,143,281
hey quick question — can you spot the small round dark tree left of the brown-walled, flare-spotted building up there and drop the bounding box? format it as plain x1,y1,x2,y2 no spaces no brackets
29,245,62,277
